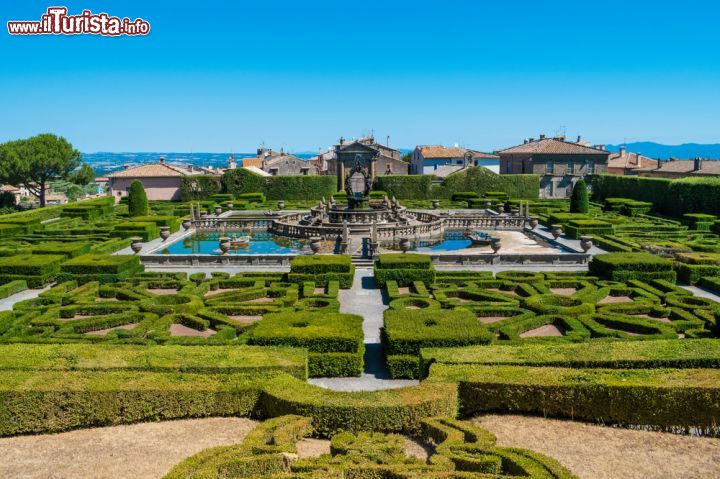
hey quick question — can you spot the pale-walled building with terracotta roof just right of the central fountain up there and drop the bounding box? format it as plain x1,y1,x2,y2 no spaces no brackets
410,145,500,175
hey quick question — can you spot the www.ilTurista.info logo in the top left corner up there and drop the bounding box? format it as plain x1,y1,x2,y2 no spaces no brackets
7,7,150,37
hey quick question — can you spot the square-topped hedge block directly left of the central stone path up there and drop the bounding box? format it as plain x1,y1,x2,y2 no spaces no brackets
248,312,365,377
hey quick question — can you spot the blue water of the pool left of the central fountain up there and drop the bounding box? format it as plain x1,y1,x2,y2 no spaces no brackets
159,231,310,255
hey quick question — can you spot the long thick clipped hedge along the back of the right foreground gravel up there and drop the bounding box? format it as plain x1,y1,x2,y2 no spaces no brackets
430,364,720,430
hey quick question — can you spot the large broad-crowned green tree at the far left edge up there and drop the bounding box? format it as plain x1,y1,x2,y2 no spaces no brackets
0,133,82,206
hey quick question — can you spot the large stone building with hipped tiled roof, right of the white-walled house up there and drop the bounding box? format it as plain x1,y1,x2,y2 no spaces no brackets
498,135,610,198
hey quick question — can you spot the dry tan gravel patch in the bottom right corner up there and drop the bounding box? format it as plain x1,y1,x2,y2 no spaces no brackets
474,415,720,479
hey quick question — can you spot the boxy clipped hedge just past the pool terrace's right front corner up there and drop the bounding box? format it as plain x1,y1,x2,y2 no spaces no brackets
588,253,676,283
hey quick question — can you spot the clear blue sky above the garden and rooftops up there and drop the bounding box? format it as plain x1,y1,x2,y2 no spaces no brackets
0,0,720,152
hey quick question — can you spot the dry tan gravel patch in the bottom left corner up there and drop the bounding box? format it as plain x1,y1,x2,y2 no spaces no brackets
0,418,256,479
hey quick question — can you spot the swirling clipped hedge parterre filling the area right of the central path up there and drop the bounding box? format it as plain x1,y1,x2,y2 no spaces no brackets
382,270,720,378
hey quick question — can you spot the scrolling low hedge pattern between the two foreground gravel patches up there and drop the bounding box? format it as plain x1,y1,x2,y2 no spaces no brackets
165,415,575,479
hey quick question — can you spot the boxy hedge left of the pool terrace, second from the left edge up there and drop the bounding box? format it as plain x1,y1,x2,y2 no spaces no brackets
62,254,144,284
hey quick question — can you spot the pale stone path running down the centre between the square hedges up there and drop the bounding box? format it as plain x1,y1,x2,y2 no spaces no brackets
308,269,418,391
